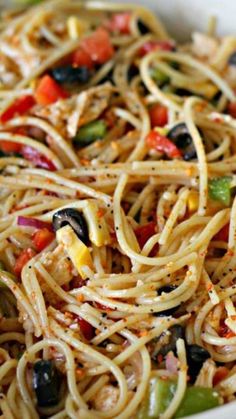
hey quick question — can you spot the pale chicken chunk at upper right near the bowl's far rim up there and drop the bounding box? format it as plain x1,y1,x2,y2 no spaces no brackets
192,32,219,60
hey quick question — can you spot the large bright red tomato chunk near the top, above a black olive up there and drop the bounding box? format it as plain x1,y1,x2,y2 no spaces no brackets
81,28,115,64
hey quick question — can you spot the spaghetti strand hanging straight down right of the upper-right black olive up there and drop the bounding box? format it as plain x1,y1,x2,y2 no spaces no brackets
184,97,208,215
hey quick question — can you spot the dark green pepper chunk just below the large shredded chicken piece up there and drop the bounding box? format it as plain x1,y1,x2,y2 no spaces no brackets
73,119,107,147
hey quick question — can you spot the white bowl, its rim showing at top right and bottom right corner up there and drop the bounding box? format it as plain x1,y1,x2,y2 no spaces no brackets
113,0,236,419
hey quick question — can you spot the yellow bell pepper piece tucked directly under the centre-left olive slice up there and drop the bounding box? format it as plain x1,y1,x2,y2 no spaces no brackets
56,225,94,279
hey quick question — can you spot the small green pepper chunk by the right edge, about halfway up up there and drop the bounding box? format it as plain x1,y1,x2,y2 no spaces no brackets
209,176,232,206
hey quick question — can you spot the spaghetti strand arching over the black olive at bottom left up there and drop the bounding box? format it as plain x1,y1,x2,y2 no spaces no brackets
16,339,86,418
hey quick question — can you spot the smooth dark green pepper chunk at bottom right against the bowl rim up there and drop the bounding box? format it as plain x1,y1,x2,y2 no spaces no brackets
175,387,219,419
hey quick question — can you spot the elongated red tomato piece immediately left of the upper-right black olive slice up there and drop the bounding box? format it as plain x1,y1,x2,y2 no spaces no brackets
146,131,181,159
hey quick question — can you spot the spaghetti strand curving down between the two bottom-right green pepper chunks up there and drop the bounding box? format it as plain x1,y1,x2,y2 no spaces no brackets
160,339,188,419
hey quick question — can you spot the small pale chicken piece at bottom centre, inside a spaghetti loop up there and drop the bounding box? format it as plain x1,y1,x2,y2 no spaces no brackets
92,384,119,412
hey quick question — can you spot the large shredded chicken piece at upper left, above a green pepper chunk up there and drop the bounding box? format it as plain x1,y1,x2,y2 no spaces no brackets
35,83,114,138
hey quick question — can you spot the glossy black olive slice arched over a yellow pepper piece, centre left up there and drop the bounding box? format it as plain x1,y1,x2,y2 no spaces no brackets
52,208,89,244
